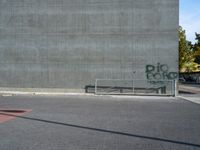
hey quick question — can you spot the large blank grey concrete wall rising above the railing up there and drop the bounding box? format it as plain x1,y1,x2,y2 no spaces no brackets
0,0,179,89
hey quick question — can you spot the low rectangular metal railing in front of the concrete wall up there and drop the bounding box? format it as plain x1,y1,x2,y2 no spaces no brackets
95,79,176,96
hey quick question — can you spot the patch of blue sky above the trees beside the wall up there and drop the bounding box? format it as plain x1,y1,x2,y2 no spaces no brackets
179,0,200,43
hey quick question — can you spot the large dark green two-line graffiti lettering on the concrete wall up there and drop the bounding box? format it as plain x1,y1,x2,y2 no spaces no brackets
146,63,178,80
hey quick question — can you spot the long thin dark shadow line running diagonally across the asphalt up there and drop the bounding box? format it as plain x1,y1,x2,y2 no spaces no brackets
0,112,200,148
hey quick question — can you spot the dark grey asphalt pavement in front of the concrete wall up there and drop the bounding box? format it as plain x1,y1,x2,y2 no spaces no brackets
0,95,200,150
